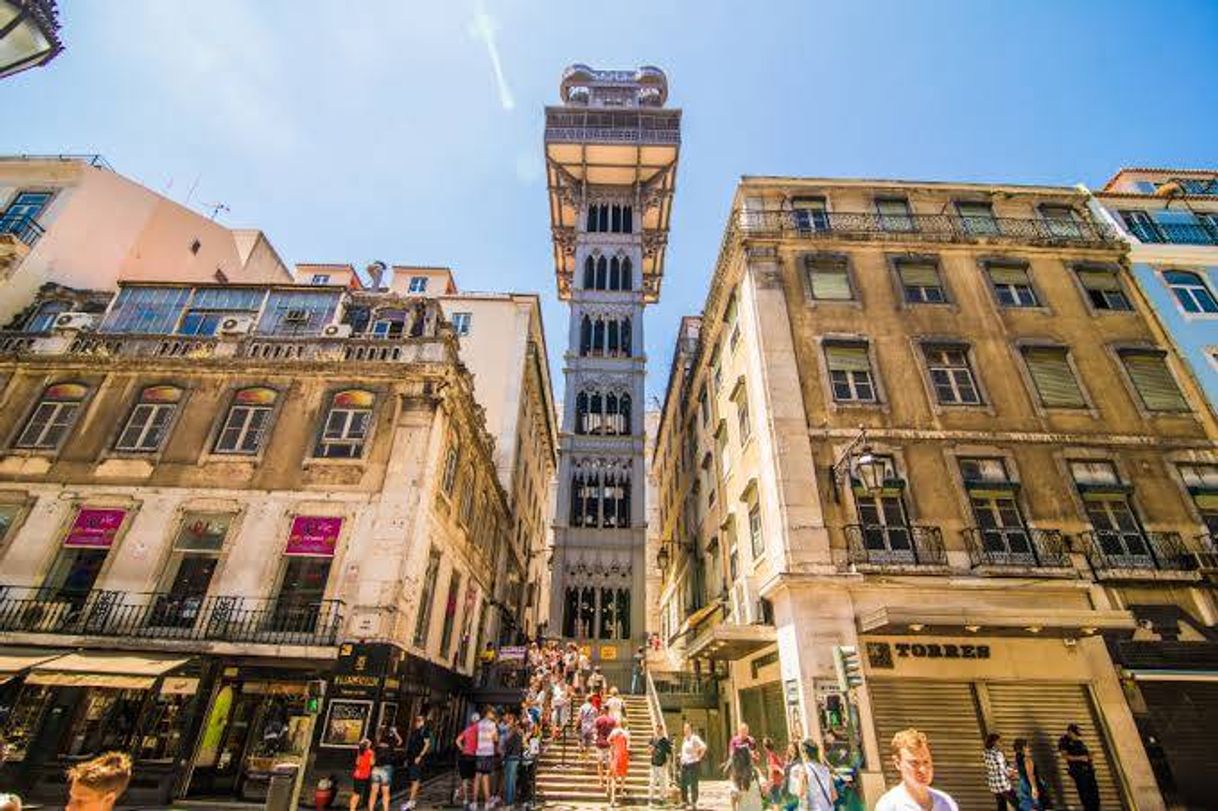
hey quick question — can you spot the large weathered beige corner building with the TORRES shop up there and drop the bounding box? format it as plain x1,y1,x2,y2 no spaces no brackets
653,178,1218,809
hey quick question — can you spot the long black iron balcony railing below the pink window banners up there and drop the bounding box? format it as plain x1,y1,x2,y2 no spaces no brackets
0,586,343,645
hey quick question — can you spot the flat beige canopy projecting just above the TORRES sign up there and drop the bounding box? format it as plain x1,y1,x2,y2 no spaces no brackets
859,605,1138,638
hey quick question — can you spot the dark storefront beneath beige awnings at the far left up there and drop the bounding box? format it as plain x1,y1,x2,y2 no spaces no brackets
0,651,202,802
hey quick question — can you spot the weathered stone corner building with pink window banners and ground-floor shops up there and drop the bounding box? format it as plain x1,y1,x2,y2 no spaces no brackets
0,283,513,802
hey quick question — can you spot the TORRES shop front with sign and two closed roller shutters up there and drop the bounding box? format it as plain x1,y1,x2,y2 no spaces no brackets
861,628,1132,809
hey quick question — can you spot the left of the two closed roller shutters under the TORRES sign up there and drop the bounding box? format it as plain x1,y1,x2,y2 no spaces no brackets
867,679,994,811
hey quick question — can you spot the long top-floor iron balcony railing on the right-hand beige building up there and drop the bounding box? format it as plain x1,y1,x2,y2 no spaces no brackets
736,211,1118,245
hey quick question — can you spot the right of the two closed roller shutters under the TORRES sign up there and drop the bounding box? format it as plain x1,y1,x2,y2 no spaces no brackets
984,683,1127,809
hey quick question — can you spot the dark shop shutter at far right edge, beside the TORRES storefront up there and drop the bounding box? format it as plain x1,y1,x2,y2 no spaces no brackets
1138,681,1218,809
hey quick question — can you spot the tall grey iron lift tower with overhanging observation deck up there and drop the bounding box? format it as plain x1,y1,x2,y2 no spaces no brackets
546,65,681,672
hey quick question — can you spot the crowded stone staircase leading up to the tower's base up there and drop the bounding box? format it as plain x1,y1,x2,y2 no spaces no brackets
537,695,654,806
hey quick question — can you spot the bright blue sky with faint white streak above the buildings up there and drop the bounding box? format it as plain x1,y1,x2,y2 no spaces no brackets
9,0,1218,393
